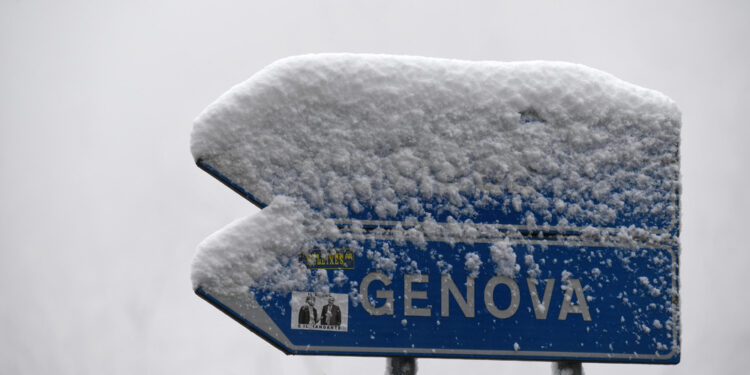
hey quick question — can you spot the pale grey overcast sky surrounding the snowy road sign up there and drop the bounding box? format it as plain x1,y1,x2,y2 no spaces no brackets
0,0,750,375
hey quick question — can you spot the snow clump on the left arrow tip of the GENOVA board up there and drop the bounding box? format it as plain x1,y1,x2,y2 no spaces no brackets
192,197,338,294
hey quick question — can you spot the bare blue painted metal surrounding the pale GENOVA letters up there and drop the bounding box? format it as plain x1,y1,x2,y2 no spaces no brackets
196,161,680,364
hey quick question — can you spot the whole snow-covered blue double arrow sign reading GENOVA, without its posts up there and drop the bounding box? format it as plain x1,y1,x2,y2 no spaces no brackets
192,54,680,363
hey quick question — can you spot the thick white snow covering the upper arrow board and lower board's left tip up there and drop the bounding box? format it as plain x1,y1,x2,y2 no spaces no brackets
191,54,680,291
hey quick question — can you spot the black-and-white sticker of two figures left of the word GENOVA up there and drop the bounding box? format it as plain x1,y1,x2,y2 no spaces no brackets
290,292,349,332
